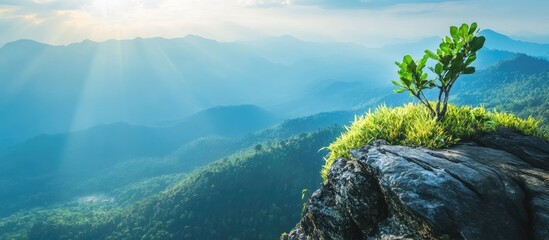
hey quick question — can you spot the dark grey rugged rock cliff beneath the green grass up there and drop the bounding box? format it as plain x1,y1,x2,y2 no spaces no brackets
289,129,549,240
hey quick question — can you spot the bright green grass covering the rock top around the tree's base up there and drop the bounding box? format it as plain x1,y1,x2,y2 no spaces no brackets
322,104,549,180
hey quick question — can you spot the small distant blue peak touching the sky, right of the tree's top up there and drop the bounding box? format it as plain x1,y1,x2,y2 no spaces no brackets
480,29,549,59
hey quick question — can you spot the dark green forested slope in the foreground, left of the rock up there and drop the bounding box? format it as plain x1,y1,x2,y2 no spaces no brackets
0,127,342,239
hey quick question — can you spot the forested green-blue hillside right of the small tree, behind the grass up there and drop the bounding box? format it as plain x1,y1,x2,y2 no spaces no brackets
452,55,549,127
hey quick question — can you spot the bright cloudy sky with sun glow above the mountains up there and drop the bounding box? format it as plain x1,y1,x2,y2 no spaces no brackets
0,0,549,46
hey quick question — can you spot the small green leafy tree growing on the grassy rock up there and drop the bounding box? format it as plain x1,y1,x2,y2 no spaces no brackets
393,22,486,121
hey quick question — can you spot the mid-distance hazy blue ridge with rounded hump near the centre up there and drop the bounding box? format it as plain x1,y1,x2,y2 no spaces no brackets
1,105,276,174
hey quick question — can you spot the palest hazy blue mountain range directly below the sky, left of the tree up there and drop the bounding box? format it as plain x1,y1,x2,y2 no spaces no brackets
0,36,383,146
